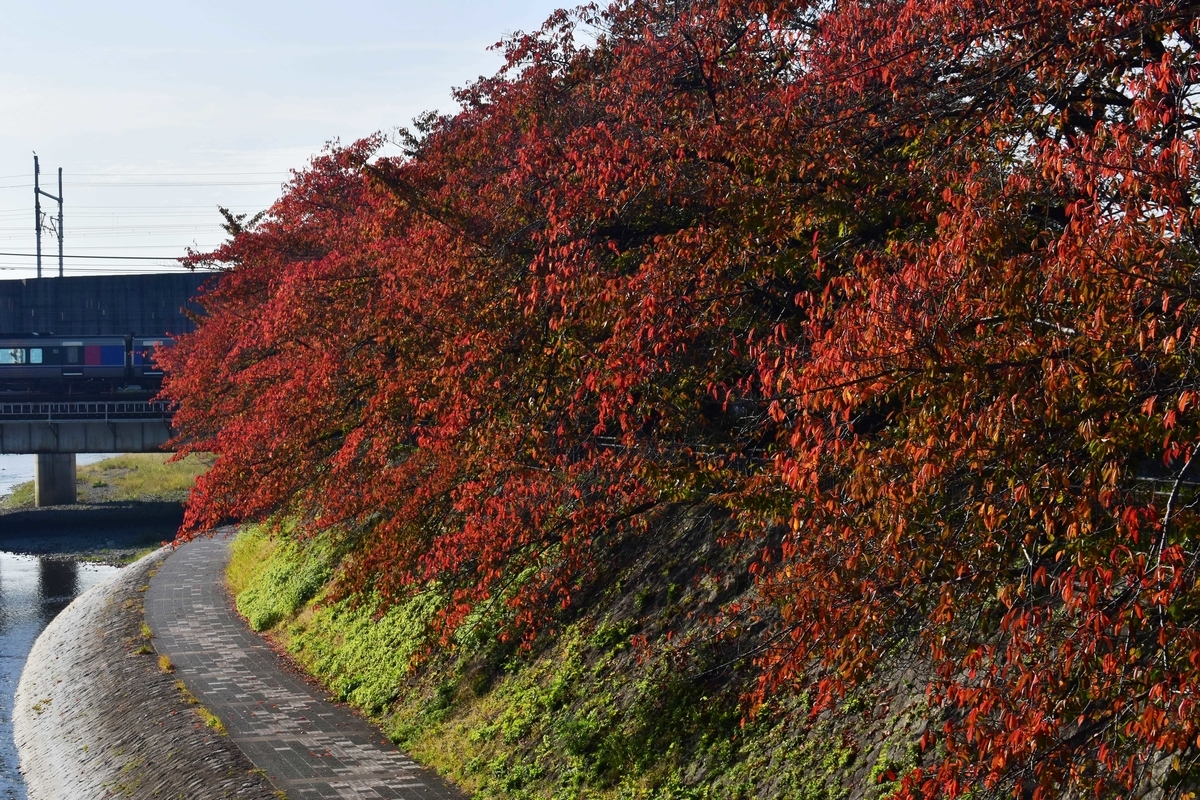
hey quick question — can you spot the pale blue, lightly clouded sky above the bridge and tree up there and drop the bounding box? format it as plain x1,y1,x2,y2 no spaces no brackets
0,0,574,279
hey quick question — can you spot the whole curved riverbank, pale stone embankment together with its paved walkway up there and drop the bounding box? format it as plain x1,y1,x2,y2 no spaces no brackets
13,536,464,800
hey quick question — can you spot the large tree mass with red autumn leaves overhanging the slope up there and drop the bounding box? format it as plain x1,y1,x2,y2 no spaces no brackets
166,0,1200,796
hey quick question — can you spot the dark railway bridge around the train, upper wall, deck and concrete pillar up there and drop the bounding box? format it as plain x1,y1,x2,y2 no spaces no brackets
0,272,214,506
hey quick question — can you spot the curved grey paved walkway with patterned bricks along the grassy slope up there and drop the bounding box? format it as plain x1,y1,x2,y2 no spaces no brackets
145,539,464,800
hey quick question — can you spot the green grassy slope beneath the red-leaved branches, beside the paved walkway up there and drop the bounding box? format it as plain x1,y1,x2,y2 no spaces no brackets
228,513,920,800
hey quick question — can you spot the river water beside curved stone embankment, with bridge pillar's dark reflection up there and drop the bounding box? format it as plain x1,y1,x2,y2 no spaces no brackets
0,552,118,800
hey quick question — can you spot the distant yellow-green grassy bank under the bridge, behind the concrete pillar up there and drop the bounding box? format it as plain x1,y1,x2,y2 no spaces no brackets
0,453,208,509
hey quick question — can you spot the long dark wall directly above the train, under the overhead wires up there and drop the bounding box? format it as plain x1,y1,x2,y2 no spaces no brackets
0,271,216,336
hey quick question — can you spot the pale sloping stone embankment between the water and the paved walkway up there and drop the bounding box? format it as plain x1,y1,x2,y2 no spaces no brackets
13,551,278,800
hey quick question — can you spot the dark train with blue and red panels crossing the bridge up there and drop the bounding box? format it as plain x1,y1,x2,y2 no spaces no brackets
0,333,175,397
